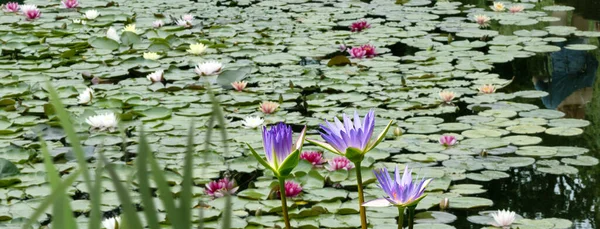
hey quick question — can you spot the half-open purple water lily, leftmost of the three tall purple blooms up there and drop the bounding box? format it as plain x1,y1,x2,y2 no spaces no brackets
248,122,306,178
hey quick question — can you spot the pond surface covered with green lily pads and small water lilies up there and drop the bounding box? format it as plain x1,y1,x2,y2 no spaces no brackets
0,0,600,229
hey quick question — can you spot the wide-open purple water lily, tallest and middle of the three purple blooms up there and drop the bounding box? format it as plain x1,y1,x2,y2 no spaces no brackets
307,110,392,164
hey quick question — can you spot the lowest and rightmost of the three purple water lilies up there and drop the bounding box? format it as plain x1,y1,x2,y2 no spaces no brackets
363,166,431,207
